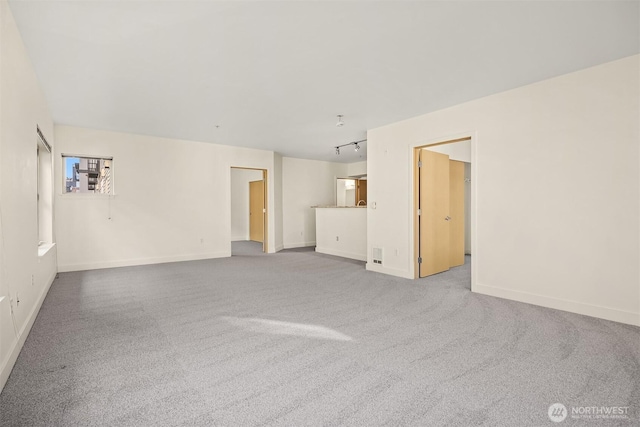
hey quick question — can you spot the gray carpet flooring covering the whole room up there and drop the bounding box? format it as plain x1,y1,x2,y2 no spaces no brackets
0,242,640,426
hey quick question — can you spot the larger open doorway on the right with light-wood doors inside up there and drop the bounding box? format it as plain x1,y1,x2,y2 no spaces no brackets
413,137,473,278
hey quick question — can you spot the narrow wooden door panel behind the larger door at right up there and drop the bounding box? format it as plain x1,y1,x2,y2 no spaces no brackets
449,160,464,267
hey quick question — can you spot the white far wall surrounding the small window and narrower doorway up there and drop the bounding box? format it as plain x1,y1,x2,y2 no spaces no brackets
55,126,275,271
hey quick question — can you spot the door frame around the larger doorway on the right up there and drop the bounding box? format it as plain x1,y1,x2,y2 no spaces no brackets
409,132,479,291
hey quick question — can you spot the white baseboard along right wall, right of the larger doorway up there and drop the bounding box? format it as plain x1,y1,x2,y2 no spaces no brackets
472,284,640,326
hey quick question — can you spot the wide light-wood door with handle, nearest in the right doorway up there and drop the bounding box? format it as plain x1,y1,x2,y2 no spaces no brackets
419,149,451,277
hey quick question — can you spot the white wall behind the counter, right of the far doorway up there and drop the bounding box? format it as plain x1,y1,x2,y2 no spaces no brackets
282,157,348,248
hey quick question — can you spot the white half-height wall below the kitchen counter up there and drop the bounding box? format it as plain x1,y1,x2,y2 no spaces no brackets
315,208,367,261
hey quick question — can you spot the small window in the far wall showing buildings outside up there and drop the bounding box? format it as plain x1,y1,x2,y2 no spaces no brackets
62,155,113,194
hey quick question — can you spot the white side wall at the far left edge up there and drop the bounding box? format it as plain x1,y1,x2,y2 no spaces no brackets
0,1,56,389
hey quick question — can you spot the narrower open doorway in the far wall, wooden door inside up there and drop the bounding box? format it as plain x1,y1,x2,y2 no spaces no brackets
231,167,268,256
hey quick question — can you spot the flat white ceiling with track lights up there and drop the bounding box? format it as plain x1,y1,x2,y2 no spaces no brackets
10,0,640,162
